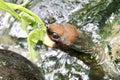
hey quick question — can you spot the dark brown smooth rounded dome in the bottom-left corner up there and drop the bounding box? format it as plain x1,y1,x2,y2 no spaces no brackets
0,49,44,80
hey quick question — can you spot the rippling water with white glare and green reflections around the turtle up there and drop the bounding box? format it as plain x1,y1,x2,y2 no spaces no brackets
0,0,120,80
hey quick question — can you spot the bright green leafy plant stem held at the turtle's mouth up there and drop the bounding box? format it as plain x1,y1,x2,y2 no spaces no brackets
0,0,46,59
